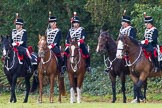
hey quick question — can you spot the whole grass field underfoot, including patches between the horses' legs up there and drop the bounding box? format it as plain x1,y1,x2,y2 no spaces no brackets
0,93,162,108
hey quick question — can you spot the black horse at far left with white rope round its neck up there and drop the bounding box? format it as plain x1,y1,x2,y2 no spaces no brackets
0,36,37,103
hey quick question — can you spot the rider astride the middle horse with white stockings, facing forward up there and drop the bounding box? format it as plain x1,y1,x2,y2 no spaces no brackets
64,12,91,72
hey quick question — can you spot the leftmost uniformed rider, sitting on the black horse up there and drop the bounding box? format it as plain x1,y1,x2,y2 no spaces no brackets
11,13,32,72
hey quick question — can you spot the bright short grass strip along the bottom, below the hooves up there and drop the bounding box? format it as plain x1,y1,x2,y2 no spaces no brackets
0,102,162,108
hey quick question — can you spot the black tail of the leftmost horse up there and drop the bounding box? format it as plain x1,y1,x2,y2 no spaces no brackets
30,70,39,93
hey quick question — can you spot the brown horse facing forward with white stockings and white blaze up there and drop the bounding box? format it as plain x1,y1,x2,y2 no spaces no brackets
67,39,86,103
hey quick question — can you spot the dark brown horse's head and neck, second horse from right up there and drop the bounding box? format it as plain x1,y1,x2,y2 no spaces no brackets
96,31,116,53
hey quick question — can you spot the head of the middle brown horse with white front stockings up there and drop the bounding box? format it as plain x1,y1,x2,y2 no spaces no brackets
69,39,79,63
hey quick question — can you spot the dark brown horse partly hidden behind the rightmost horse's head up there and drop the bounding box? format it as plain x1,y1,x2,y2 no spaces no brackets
96,31,129,103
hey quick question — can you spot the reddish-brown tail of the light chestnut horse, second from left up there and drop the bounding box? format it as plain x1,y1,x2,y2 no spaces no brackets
58,76,66,96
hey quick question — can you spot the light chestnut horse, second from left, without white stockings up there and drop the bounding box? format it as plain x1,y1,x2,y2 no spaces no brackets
38,35,65,103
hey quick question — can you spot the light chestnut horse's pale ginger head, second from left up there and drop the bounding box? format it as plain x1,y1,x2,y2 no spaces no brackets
38,35,48,58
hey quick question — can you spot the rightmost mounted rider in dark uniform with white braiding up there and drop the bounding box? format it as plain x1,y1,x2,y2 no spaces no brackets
141,12,160,72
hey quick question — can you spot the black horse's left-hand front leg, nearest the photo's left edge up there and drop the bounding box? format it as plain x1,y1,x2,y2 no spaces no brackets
10,74,17,103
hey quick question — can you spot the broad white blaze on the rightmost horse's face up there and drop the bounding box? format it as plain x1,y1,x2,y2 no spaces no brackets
116,40,124,59
